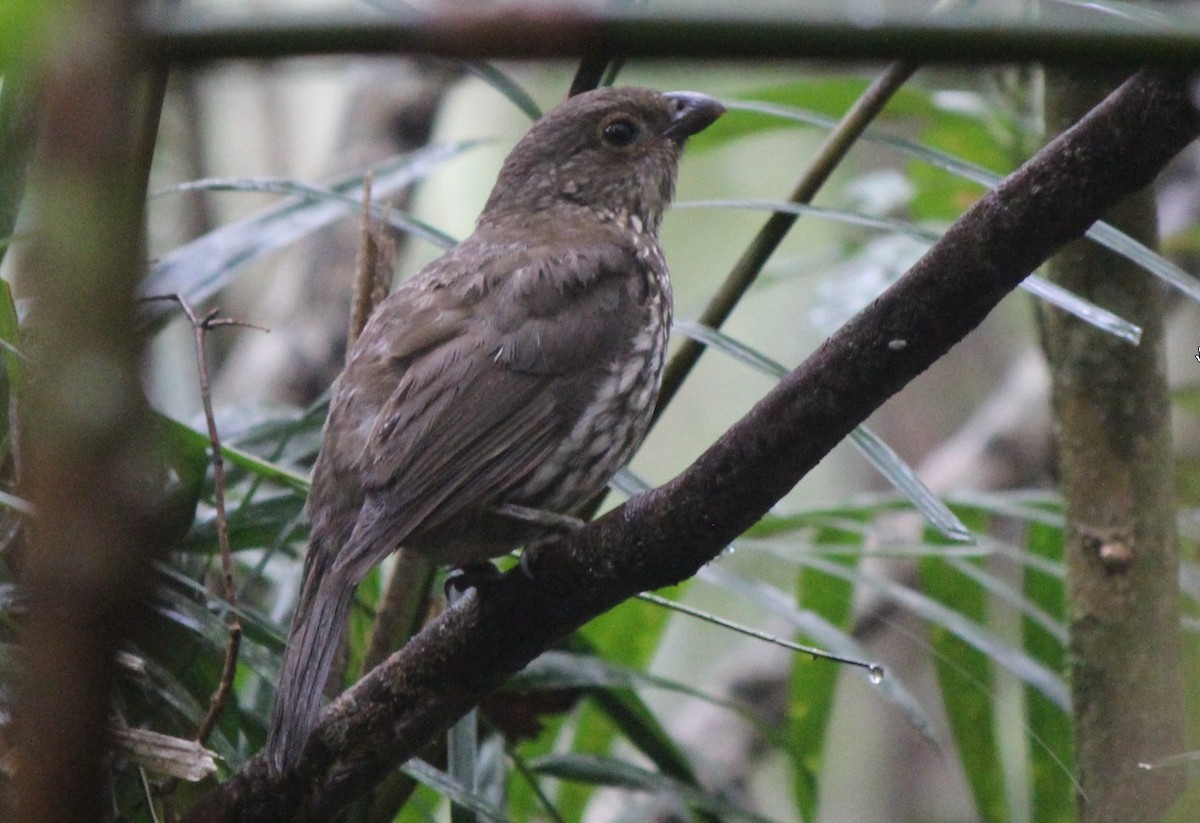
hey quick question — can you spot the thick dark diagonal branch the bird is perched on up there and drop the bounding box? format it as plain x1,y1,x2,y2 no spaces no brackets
177,72,1200,823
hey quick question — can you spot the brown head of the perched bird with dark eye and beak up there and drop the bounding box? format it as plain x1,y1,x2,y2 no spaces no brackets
480,88,725,232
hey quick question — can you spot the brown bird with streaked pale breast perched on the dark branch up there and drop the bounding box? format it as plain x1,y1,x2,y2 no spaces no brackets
266,88,725,773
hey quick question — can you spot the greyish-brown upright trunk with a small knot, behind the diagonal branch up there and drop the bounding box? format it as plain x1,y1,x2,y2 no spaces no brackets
1043,70,1184,823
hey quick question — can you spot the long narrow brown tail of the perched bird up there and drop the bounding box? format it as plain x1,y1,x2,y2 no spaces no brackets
266,554,355,773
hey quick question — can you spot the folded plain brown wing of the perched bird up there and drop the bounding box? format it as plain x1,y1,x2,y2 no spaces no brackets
330,239,646,580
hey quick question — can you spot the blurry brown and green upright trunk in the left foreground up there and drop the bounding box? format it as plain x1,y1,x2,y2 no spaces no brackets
10,0,166,823
